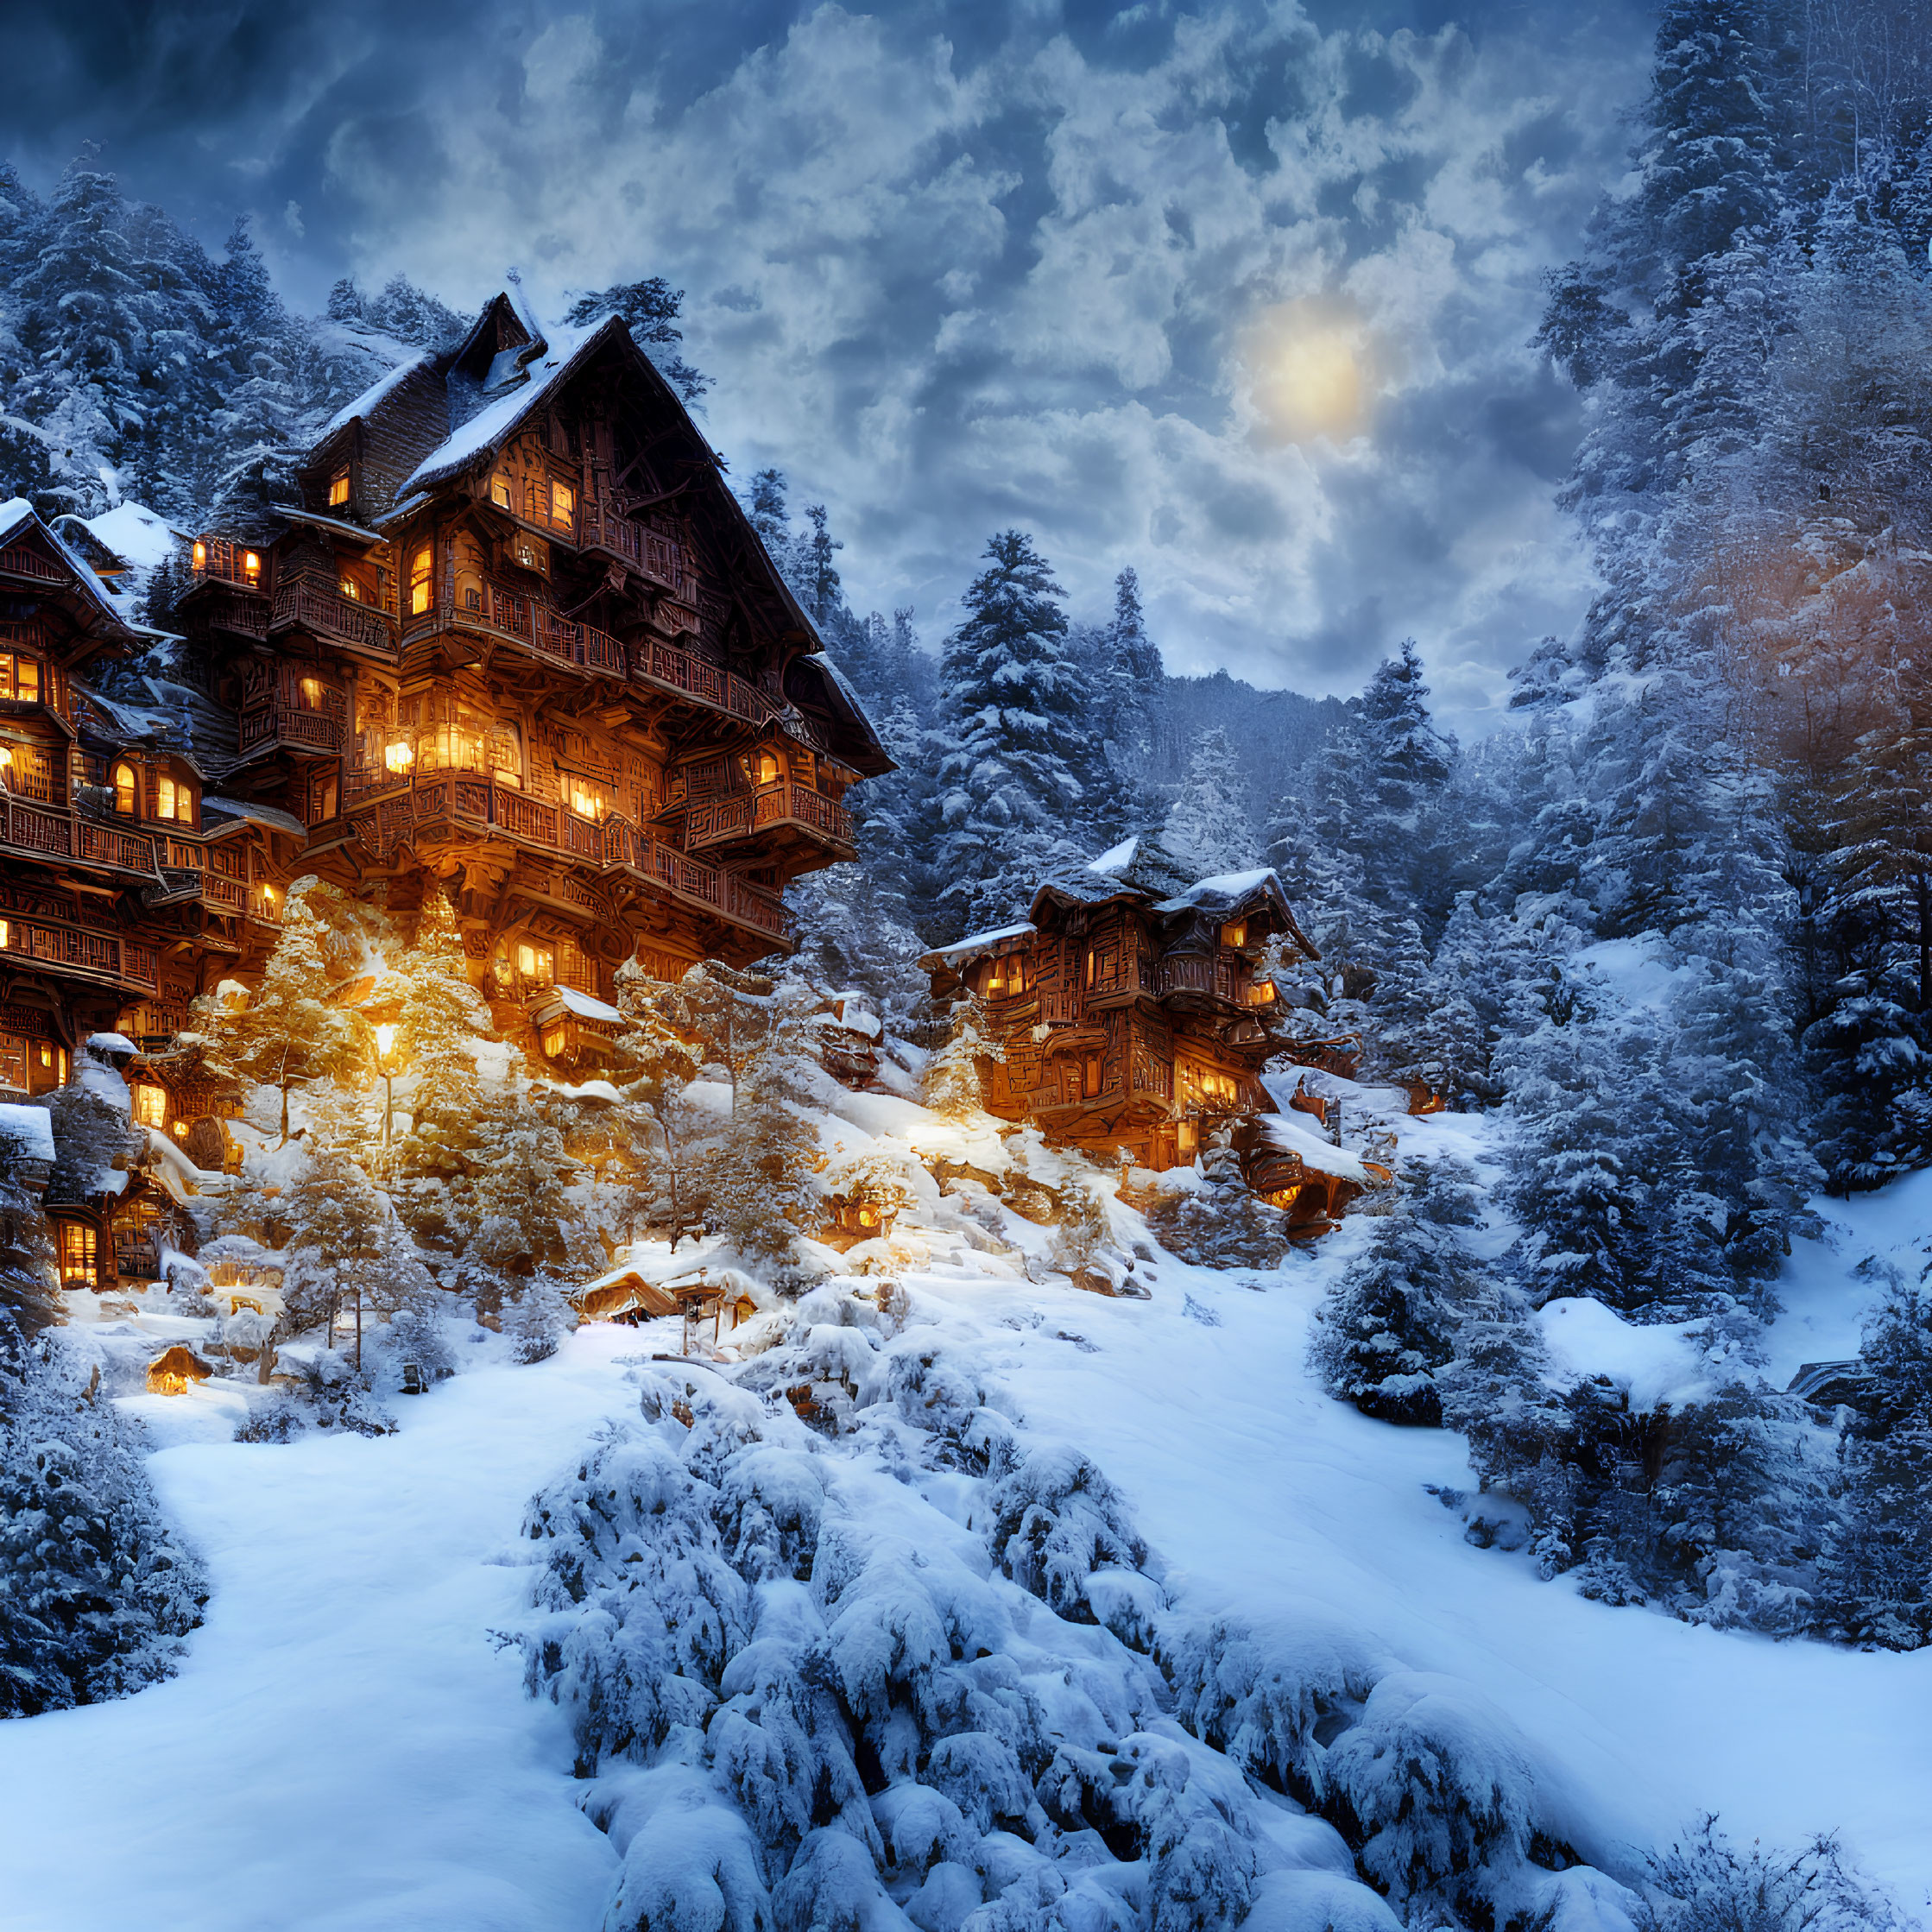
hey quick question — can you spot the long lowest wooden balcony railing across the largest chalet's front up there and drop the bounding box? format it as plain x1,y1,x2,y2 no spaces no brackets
348,771,790,944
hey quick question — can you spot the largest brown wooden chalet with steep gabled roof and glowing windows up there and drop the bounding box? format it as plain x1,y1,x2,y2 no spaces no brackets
180,283,891,1055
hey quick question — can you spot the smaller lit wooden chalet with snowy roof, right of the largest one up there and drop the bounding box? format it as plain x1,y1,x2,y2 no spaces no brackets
919,837,1317,1169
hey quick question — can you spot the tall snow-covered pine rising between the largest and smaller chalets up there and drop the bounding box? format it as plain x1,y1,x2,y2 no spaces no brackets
931,529,1097,929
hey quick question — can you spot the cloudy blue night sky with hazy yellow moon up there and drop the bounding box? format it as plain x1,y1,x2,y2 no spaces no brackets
8,0,1651,730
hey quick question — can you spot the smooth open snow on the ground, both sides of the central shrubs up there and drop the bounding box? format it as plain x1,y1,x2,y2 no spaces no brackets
0,1095,1932,1932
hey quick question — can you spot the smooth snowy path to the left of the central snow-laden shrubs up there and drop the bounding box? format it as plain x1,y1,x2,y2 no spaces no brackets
0,1328,640,1932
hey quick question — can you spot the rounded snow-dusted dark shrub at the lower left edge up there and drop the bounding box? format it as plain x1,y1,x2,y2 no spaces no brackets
0,1354,206,1718
